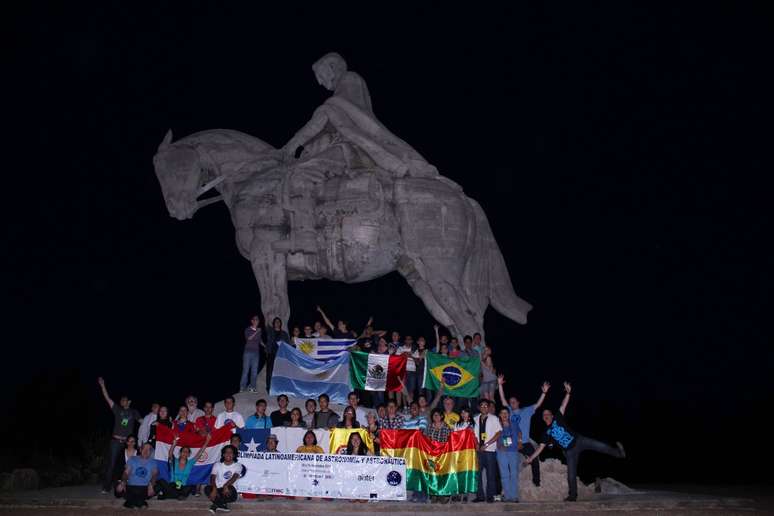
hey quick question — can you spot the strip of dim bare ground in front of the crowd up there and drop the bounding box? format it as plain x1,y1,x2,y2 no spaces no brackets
0,486,774,516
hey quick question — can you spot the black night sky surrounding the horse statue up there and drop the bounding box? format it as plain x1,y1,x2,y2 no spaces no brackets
0,2,774,483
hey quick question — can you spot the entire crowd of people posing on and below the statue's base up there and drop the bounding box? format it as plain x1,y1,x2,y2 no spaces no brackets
99,307,625,511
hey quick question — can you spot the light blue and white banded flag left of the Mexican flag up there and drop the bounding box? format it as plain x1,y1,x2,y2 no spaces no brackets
270,342,350,405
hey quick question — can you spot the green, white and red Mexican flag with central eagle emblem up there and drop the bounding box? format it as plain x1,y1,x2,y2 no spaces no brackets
349,351,406,392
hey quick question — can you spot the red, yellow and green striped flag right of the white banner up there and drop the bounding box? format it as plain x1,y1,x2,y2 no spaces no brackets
379,429,478,496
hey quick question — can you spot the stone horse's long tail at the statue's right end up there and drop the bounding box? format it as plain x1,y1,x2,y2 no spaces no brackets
462,198,532,324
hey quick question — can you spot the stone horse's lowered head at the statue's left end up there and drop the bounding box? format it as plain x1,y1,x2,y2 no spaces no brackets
153,131,203,220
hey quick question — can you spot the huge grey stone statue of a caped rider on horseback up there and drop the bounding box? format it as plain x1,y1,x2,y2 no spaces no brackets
153,54,531,337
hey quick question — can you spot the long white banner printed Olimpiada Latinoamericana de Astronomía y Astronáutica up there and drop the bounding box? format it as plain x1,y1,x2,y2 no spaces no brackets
237,452,406,500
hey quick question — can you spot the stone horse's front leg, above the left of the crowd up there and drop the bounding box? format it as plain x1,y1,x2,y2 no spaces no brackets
250,230,290,328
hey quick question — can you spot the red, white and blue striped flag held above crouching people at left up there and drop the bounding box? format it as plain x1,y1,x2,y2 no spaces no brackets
153,425,231,486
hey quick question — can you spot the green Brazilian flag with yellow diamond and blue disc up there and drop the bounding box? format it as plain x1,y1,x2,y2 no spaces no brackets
422,351,481,398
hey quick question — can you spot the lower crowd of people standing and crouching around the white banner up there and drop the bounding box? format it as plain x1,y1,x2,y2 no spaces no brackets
99,364,625,512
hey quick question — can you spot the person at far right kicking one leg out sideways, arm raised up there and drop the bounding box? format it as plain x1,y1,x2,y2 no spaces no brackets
527,382,626,502
